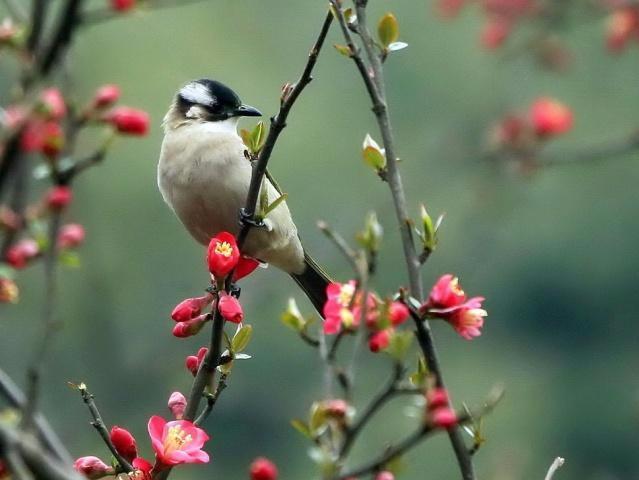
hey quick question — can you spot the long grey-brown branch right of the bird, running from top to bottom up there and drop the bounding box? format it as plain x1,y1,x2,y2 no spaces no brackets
331,0,475,480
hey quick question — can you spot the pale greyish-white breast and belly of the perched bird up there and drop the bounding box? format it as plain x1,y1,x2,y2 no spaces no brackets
158,119,304,272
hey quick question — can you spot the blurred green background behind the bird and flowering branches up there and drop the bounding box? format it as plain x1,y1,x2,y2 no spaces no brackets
0,0,639,480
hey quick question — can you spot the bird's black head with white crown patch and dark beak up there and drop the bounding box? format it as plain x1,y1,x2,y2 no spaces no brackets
165,78,262,126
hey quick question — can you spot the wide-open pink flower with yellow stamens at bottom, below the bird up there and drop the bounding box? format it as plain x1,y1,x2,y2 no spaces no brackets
148,416,209,466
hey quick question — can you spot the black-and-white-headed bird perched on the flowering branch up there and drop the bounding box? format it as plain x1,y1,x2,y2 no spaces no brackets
157,78,331,315
